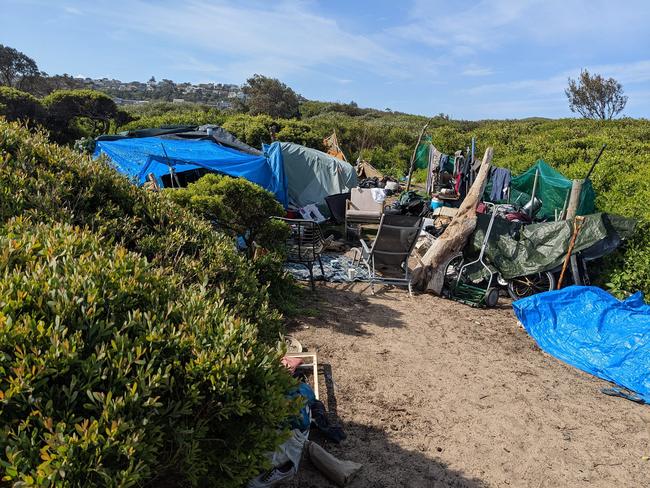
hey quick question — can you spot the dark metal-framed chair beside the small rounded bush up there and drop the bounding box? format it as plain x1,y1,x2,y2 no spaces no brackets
273,217,325,291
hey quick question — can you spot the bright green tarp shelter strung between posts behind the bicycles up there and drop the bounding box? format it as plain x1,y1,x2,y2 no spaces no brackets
484,159,595,219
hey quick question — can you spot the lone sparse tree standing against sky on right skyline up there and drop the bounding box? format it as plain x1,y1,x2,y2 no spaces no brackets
564,69,627,120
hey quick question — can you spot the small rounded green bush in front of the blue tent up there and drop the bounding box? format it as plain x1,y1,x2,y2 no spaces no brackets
166,174,288,254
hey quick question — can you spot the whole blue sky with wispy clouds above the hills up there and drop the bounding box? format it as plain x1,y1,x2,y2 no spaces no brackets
0,0,650,119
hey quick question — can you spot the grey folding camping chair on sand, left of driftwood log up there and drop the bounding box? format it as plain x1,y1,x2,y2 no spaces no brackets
360,214,424,296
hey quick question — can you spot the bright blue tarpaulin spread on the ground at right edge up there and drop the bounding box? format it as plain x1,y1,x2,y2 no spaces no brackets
512,286,650,403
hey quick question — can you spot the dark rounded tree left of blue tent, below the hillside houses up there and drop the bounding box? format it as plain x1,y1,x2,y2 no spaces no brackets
43,90,118,142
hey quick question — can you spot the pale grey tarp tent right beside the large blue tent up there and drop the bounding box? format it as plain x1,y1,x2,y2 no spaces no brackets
272,142,357,207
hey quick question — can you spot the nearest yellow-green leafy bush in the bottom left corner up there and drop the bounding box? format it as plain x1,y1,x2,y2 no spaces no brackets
0,220,291,487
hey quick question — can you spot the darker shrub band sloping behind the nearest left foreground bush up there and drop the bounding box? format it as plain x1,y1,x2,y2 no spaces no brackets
0,122,294,342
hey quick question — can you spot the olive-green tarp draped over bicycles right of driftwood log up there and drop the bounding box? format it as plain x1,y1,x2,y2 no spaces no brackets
465,213,635,279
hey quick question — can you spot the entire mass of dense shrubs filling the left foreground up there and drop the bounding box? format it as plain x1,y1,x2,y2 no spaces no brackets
0,120,293,487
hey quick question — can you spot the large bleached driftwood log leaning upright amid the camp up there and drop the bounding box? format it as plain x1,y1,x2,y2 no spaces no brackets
413,147,493,295
